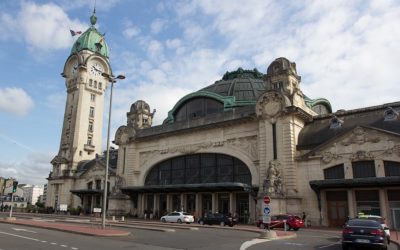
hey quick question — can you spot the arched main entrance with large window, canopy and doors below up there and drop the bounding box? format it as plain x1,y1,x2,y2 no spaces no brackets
123,153,258,222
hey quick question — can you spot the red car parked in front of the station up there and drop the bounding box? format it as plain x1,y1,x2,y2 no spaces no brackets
256,214,304,231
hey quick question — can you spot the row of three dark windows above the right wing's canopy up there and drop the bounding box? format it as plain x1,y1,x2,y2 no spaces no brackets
324,161,400,179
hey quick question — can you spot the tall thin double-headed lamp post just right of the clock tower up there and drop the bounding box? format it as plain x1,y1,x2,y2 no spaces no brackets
101,73,125,229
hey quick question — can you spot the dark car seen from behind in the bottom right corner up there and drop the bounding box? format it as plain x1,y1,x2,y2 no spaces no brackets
342,219,388,250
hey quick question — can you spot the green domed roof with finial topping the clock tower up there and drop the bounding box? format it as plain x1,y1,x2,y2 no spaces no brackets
71,13,110,58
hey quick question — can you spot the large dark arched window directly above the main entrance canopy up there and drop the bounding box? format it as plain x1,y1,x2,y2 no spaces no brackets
145,153,251,185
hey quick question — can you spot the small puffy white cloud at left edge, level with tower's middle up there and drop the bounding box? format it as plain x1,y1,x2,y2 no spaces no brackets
0,88,34,116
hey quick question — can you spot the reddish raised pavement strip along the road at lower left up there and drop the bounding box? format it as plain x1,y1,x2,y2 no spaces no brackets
0,218,130,237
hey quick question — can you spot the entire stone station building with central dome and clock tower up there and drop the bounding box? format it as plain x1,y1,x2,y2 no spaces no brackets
46,15,400,228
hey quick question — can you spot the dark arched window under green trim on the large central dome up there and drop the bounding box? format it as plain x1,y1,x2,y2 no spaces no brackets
175,97,224,121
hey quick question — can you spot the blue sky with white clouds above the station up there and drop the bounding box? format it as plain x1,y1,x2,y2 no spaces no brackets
0,0,400,185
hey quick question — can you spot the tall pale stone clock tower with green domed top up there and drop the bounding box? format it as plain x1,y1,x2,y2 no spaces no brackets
46,12,112,209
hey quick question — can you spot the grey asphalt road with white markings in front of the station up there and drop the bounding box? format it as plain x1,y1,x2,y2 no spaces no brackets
0,213,397,250
